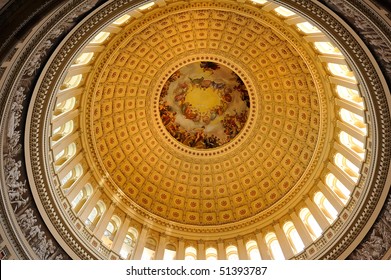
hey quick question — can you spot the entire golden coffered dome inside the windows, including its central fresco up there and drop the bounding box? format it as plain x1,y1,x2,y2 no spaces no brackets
86,2,333,225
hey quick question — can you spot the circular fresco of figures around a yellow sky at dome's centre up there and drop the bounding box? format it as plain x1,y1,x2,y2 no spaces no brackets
159,61,250,149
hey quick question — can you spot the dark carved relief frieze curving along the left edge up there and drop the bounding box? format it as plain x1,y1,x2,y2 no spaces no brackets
1,1,103,259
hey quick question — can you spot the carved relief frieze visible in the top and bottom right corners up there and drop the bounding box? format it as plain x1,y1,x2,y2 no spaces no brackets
323,0,391,260
